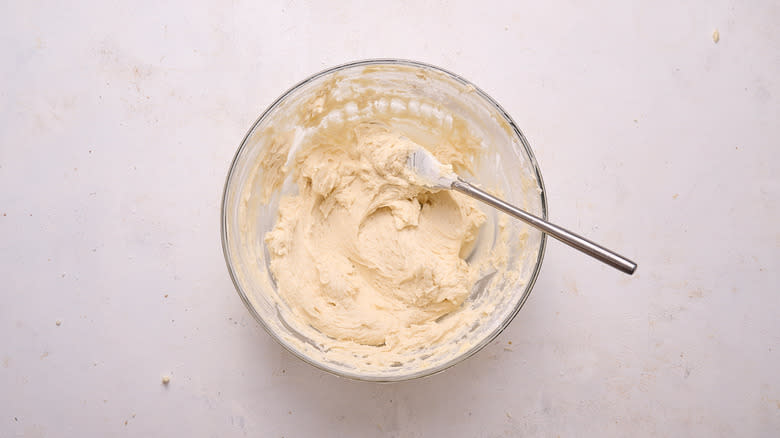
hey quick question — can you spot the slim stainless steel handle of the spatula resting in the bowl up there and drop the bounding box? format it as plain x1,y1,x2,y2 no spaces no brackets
452,178,636,275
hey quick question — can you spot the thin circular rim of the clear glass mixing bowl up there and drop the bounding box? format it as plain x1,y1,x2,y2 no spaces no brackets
220,58,548,383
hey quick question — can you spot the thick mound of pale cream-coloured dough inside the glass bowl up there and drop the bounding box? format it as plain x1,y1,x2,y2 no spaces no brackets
265,122,485,351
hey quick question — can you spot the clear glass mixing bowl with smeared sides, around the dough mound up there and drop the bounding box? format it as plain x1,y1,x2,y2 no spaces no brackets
221,59,547,382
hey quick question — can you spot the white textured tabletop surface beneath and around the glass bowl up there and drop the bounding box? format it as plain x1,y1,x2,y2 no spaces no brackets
0,0,780,437
